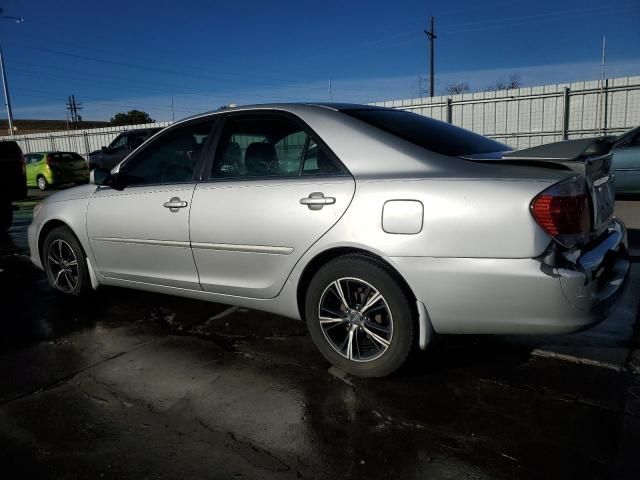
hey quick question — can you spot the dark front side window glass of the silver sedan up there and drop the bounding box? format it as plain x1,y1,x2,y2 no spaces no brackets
120,121,213,185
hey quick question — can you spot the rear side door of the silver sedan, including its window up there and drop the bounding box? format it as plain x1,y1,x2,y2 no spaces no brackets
191,113,355,298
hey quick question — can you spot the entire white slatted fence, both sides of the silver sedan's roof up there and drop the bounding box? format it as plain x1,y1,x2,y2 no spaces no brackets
4,77,640,156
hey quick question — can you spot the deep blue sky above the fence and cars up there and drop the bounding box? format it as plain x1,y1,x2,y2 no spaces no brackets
0,0,640,120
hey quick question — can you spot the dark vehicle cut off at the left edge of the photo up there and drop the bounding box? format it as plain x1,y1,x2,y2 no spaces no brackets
0,141,27,232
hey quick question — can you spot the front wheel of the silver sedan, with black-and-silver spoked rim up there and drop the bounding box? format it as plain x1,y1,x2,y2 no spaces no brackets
42,227,91,297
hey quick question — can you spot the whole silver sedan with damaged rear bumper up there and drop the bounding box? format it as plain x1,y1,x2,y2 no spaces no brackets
29,104,629,377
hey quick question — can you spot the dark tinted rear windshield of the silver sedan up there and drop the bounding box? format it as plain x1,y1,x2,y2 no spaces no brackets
341,108,510,156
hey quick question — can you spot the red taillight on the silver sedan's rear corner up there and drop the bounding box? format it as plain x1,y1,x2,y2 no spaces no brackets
531,177,591,248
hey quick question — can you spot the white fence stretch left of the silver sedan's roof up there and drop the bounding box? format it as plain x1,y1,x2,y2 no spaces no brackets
6,122,171,157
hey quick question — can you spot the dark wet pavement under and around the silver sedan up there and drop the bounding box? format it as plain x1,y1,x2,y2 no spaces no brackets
0,189,640,479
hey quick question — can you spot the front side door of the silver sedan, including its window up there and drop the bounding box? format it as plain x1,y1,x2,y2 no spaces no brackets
87,120,212,289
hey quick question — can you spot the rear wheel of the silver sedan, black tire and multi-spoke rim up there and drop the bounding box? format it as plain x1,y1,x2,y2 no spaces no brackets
305,255,416,377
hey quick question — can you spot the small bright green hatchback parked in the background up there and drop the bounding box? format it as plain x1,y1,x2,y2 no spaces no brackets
25,152,89,190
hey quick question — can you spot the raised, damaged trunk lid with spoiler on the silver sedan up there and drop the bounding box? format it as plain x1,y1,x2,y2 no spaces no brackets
463,136,620,236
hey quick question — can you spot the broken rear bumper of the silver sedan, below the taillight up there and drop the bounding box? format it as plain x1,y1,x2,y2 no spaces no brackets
388,220,630,334
